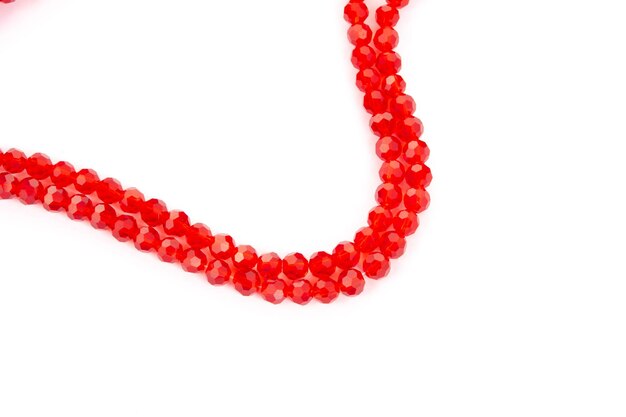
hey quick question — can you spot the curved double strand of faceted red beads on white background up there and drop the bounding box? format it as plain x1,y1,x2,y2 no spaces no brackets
0,0,432,304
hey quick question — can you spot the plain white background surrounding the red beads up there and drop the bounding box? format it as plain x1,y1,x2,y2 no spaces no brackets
0,0,626,417
